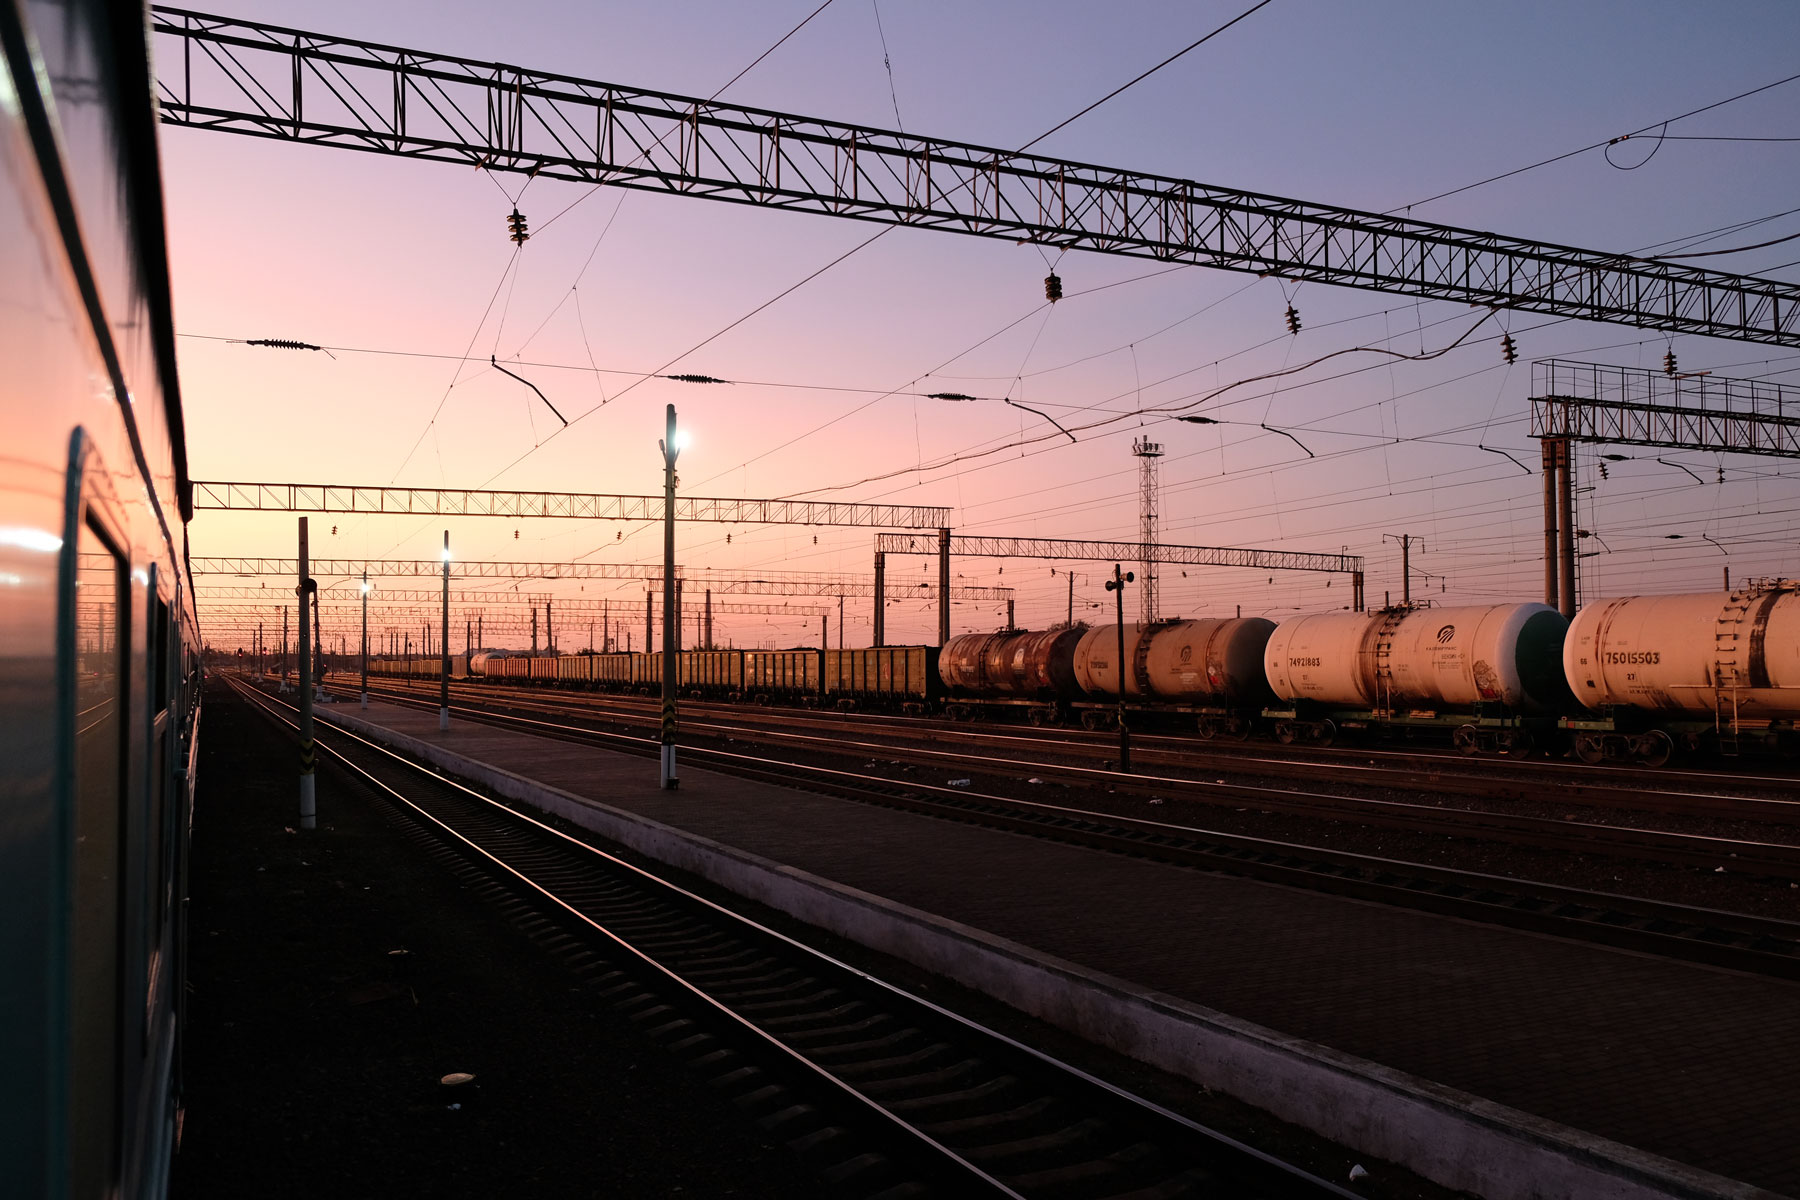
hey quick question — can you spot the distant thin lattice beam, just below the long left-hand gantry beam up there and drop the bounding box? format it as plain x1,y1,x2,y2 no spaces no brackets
193,558,1013,601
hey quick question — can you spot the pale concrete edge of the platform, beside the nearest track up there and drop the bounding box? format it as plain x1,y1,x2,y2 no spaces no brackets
319,711,1778,1200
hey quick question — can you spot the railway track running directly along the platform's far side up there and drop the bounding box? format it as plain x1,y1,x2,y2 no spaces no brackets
306,676,1800,979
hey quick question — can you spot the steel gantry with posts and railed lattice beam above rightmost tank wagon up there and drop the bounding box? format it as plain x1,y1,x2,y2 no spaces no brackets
1532,354,1800,617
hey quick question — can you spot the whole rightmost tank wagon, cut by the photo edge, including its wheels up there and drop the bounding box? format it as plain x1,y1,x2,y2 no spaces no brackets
1562,579,1800,766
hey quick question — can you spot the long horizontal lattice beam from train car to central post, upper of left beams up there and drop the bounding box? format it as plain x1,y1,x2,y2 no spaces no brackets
194,482,950,529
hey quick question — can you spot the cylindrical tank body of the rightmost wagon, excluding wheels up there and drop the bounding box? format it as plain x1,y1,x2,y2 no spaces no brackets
1562,579,1800,720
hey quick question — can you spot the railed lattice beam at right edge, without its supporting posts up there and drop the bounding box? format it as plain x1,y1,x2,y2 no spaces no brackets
1532,358,1800,459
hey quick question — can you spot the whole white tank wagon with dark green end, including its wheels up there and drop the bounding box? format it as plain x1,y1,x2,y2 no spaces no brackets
1265,604,1570,754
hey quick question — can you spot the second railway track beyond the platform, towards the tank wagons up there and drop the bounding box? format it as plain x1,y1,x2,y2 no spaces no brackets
334,676,1800,880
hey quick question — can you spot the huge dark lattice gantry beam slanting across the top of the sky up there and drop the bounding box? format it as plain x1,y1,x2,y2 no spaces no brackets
153,7,1800,345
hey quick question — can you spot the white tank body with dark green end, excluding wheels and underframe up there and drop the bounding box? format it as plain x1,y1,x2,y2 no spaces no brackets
1264,604,1568,712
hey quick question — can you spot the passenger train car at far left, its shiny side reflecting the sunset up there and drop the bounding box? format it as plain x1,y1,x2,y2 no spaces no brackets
0,0,200,1200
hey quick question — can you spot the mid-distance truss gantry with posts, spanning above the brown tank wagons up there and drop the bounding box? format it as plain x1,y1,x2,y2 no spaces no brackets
875,529,1363,646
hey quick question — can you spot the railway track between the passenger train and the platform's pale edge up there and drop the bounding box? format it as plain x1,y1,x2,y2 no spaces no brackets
234,684,1354,1200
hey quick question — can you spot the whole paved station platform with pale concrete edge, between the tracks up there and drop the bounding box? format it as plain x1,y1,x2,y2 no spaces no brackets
319,702,1800,1196
